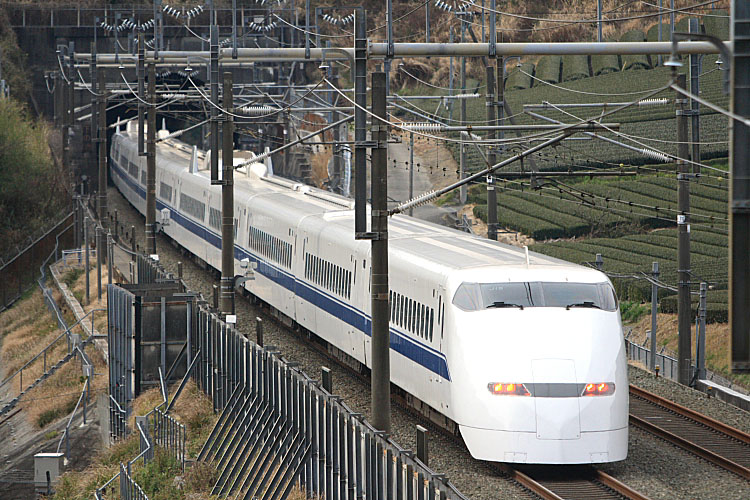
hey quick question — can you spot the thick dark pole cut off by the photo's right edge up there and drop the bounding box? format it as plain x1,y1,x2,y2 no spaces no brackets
729,1,750,373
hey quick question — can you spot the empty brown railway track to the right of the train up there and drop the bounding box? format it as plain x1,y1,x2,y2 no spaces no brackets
630,385,750,480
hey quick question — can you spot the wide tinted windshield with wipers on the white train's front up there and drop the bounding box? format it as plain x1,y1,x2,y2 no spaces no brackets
453,281,617,311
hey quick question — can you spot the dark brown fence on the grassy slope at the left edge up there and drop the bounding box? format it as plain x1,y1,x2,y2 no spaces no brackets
0,212,73,311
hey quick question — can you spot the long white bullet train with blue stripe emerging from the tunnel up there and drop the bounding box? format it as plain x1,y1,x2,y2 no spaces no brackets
110,121,628,464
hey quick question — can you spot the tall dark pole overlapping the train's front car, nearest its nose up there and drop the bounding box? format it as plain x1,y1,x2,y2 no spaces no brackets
370,71,391,433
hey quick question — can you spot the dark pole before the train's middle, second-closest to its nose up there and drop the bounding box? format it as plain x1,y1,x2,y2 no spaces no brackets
220,72,234,315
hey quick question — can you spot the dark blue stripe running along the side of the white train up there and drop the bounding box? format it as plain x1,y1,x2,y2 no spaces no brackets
110,156,450,380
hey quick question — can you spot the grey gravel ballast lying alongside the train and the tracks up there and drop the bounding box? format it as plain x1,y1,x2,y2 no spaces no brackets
108,188,750,500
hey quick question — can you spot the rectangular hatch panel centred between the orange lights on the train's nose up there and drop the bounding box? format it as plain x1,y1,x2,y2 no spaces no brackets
531,359,581,439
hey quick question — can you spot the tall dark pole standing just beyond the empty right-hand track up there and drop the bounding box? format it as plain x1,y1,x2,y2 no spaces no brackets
676,74,693,385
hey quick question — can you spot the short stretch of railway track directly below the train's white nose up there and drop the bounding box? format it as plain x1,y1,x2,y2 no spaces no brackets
500,465,648,500
